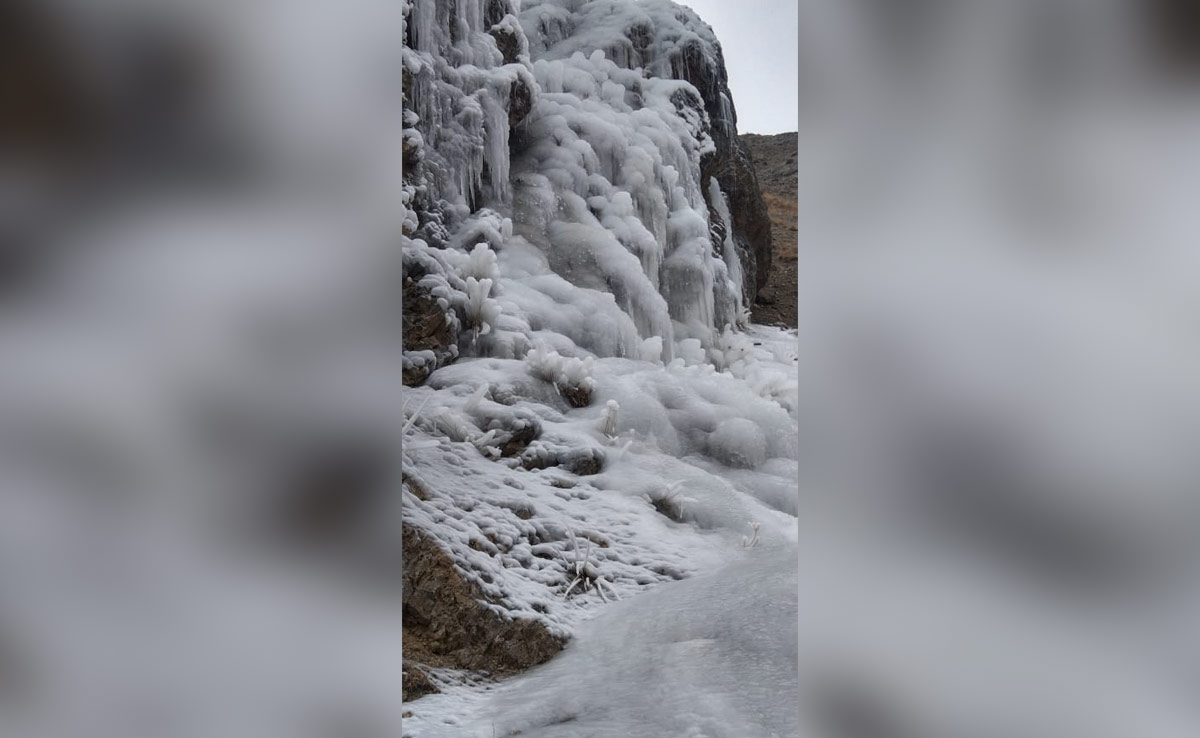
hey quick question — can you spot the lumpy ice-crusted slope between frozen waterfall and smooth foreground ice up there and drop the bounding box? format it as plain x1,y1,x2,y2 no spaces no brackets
406,329,794,632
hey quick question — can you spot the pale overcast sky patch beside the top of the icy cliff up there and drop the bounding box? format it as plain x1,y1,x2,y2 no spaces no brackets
676,0,799,133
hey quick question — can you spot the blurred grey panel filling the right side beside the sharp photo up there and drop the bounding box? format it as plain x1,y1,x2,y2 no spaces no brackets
798,0,1200,738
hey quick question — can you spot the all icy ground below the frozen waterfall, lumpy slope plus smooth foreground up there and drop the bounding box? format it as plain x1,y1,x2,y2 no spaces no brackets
404,326,797,738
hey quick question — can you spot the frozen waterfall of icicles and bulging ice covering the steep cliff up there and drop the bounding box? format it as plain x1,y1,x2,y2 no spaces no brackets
402,0,764,369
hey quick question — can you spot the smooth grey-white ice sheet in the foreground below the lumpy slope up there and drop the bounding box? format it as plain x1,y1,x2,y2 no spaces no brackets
408,546,798,738
